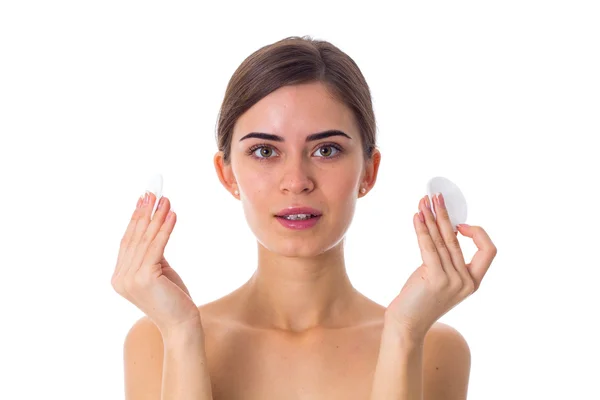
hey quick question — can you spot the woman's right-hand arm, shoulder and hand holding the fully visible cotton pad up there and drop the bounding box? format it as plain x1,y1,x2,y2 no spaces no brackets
371,193,497,400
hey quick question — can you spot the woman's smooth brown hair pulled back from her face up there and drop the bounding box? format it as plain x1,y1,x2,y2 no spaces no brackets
217,36,376,164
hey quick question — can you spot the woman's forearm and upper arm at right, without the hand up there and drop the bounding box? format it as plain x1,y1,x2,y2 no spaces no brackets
371,323,471,400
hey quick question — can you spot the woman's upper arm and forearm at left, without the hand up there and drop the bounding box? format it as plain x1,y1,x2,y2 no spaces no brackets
124,317,212,400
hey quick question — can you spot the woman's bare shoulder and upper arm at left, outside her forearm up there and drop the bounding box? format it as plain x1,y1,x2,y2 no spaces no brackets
123,316,163,400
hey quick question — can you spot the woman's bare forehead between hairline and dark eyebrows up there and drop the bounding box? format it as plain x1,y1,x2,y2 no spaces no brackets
233,83,357,140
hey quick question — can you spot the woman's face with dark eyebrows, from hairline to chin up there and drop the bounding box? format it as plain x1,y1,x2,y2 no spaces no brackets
220,83,376,257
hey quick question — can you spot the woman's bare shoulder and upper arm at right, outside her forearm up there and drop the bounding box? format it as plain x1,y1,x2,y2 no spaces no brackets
423,322,471,400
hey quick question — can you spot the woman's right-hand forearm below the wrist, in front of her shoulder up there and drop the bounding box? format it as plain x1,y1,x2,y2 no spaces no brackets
370,323,424,400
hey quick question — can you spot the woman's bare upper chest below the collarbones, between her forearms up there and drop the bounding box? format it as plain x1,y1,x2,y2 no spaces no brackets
206,327,380,400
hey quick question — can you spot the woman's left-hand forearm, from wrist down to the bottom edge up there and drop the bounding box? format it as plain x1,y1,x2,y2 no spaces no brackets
161,326,212,400
